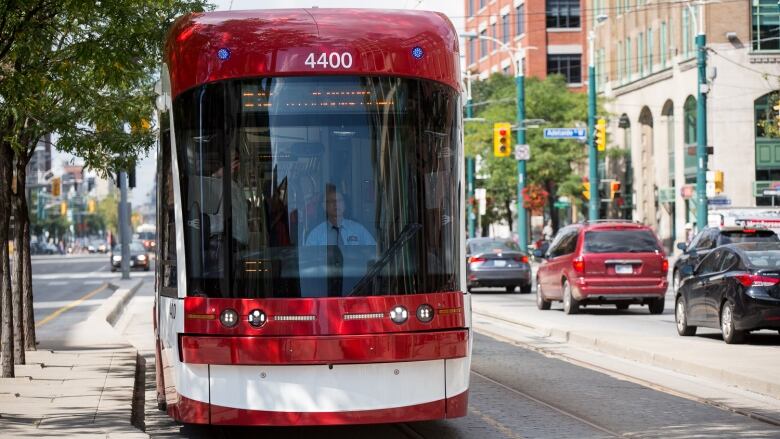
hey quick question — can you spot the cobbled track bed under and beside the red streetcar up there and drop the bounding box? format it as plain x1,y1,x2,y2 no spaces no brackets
116,282,780,438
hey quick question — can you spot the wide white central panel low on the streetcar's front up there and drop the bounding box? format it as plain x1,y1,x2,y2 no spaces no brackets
210,360,445,412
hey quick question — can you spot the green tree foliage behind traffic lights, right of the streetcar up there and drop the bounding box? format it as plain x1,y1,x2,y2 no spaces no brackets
465,74,588,224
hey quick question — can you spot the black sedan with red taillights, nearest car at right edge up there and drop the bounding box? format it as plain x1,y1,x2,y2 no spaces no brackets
674,242,780,344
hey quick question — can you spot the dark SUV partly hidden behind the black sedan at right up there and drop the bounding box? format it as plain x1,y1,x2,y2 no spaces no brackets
672,227,780,291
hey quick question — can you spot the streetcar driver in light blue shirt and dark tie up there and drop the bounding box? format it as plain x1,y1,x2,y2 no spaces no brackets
306,184,376,247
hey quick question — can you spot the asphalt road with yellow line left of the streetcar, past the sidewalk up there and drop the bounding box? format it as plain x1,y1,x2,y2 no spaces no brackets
32,254,154,348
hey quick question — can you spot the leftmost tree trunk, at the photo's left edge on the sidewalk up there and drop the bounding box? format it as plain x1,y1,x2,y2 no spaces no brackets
0,144,14,378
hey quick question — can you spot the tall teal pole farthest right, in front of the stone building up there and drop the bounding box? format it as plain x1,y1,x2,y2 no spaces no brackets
688,2,708,230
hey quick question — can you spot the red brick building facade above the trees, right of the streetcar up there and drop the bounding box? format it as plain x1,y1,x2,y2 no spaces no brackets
464,0,587,91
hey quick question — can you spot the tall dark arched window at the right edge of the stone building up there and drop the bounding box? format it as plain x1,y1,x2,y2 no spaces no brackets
753,91,780,206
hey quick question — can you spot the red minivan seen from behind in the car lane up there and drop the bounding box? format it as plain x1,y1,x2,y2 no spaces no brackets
536,220,669,314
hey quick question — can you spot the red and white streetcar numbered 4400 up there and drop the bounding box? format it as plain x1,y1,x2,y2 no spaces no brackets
155,8,472,425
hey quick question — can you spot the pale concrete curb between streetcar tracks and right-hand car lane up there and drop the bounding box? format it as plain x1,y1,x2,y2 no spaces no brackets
472,305,780,398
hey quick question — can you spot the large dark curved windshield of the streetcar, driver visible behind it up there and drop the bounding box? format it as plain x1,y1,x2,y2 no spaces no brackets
174,76,460,298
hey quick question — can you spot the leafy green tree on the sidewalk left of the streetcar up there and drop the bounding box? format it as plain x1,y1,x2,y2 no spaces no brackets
0,0,210,376
